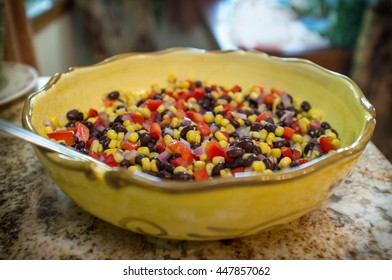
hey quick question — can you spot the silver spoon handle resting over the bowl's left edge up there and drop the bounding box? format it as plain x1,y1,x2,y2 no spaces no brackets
0,119,111,170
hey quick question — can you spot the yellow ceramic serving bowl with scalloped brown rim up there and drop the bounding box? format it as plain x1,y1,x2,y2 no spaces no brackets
23,49,375,240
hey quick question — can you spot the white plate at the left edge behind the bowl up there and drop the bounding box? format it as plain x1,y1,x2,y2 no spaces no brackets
0,61,38,105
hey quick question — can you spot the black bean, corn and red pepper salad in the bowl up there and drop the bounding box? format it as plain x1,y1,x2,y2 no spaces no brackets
44,75,341,180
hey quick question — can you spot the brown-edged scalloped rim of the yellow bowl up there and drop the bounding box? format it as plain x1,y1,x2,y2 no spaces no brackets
22,48,376,193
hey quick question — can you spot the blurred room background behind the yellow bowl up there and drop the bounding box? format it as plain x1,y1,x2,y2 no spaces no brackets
0,0,392,161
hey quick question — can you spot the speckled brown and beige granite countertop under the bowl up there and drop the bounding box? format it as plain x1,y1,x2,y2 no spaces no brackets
0,99,392,259
